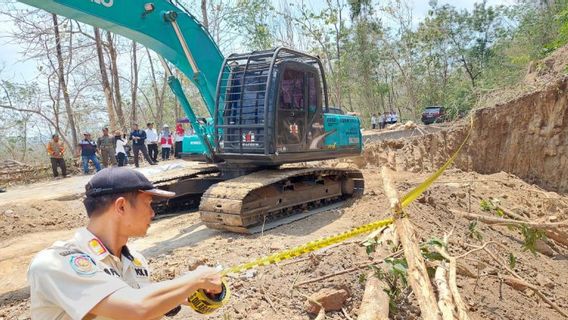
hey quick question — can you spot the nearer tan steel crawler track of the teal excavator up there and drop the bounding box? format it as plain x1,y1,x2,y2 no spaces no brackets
199,168,364,234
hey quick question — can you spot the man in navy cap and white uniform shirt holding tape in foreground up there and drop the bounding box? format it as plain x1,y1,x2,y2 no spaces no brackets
28,167,222,320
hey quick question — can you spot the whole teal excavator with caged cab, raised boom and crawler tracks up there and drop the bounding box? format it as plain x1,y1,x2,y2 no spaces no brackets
19,0,364,233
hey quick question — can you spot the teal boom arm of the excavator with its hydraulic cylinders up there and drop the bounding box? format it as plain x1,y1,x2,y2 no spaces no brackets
19,0,224,158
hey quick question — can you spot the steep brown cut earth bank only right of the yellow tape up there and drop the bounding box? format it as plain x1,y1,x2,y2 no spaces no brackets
468,78,568,193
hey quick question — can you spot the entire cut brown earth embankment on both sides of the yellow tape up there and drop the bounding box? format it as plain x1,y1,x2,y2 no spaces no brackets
358,77,568,193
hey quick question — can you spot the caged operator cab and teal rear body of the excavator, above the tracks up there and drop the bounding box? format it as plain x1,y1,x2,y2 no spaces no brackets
214,48,362,166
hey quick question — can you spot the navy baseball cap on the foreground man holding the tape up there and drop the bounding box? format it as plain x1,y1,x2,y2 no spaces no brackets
85,167,176,198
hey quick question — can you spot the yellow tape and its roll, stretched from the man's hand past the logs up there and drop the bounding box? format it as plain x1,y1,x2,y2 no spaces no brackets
189,116,473,314
